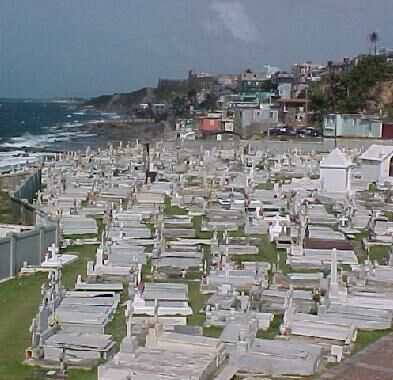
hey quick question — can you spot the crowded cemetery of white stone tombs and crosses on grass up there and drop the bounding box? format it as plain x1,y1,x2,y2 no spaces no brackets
0,139,393,380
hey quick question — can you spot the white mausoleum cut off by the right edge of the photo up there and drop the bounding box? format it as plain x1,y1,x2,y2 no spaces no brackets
360,144,393,182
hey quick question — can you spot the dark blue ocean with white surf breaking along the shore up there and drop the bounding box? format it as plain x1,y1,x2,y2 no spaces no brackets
0,98,116,172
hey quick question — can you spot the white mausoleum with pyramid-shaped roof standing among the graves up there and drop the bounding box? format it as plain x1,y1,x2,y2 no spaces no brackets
319,148,353,193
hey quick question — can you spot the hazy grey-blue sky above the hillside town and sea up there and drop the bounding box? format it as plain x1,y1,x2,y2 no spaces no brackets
0,0,393,98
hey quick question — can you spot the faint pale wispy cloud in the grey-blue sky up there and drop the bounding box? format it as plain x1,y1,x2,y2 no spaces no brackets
203,0,257,42
